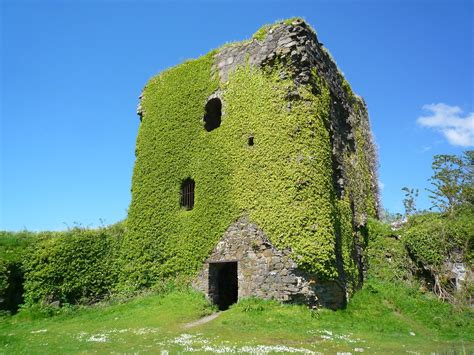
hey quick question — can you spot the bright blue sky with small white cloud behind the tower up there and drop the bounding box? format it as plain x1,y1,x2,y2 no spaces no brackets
0,0,474,230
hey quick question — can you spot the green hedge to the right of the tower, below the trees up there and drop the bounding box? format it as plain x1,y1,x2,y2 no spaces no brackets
365,208,474,287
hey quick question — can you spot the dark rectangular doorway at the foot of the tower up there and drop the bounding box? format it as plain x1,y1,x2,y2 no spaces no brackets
209,261,239,311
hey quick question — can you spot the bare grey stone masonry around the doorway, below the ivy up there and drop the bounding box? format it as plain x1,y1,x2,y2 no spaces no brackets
193,217,346,309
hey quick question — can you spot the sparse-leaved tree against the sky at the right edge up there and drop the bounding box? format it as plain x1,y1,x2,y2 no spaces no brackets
427,151,474,213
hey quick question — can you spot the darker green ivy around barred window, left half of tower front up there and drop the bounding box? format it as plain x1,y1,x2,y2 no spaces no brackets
122,53,238,289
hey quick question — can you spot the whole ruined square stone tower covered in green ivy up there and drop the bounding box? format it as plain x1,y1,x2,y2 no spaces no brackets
122,19,378,309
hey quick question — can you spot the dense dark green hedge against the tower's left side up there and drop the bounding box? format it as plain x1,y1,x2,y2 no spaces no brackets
23,223,125,305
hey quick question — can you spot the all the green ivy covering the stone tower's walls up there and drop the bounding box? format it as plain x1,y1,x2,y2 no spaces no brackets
121,20,377,289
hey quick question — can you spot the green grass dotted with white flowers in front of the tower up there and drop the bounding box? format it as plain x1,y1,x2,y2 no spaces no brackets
0,281,474,354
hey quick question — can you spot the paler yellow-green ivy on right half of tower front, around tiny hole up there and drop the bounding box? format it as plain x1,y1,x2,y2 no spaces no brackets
219,67,337,278
